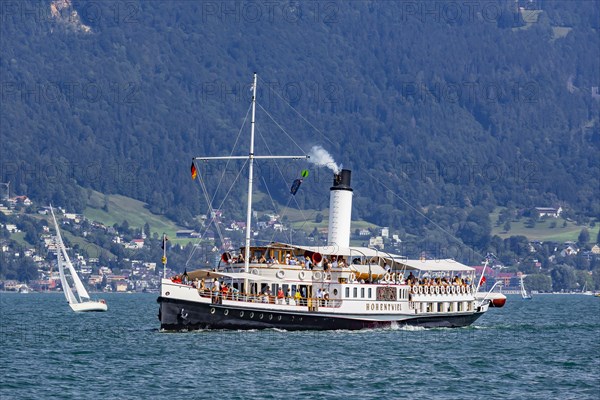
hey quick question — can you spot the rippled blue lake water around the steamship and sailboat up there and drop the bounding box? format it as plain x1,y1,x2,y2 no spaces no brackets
0,293,600,400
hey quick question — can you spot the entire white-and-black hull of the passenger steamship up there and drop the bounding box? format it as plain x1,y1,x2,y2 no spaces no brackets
157,279,488,331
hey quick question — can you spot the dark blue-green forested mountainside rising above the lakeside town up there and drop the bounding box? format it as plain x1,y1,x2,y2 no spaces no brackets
0,0,600,252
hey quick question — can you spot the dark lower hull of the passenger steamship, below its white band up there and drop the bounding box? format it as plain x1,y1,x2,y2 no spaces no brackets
157,297,483,331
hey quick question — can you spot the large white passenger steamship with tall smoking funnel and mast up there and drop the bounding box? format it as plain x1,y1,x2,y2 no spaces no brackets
157,75,506,331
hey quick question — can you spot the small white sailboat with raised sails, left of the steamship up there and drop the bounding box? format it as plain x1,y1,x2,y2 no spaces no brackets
50,206,108,311
